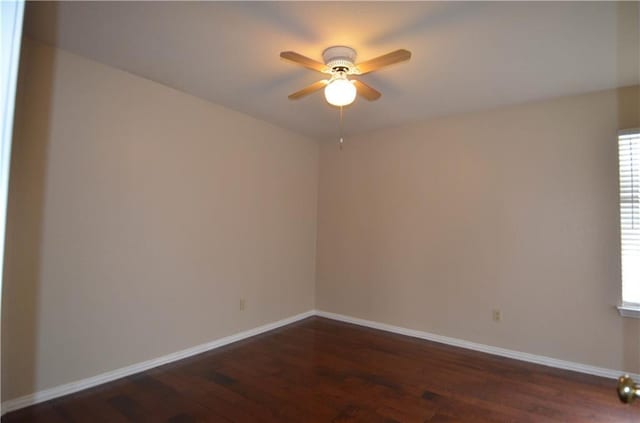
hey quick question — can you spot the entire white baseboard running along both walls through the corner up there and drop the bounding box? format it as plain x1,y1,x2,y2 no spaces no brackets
1,310,640,414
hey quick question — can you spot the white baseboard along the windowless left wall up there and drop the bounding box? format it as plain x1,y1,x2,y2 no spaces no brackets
1,310,315,415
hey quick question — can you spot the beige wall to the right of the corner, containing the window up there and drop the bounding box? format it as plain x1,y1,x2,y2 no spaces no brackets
316,87,640,372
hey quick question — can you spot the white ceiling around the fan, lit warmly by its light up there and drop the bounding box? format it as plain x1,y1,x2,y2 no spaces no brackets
25,2,640,139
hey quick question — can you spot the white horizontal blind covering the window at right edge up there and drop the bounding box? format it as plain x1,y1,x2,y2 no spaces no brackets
618,129,640,306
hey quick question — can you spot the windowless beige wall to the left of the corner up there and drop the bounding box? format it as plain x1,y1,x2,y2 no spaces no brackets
2,42,318,400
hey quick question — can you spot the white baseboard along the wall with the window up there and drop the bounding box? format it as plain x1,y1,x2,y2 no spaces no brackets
315,310,640,380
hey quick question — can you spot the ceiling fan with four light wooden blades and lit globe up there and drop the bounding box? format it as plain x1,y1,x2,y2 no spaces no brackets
280,46,411,106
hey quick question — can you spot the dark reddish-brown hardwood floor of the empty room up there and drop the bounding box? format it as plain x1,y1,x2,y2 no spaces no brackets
2,317,640,423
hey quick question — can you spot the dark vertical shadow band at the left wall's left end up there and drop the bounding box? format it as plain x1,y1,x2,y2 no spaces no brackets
2,4,55,401
